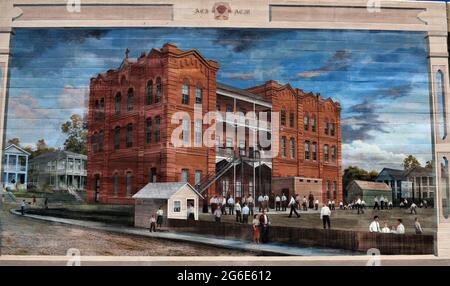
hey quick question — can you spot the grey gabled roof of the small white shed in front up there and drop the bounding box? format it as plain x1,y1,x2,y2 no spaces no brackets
133,182,203,199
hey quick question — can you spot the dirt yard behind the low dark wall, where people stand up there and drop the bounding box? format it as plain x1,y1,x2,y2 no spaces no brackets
200,208,436,234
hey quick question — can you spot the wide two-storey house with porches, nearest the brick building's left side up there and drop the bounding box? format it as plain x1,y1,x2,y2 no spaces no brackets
28,150,87,191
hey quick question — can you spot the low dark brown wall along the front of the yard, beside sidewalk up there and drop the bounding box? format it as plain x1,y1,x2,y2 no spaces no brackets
168,220,434,255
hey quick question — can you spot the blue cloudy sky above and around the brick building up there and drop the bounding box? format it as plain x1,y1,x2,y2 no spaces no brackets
6,28,432,171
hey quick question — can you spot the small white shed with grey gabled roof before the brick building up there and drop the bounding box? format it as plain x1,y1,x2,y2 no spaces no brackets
133,182,203,228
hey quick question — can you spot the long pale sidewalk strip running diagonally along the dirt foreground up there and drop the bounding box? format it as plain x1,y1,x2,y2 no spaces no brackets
10,209,355,256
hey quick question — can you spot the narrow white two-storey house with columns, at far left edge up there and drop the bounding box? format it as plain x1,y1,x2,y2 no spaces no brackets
3,144,30,190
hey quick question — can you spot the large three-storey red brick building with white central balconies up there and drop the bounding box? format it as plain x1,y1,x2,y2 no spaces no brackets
87,44,342,204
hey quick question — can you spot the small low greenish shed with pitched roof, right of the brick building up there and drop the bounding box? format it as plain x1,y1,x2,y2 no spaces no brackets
347,180,392,206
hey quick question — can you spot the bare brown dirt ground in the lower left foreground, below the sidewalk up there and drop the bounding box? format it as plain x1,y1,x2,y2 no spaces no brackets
0,206,255,256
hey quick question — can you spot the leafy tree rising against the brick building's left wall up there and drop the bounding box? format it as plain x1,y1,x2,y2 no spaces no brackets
61,114,87,155
